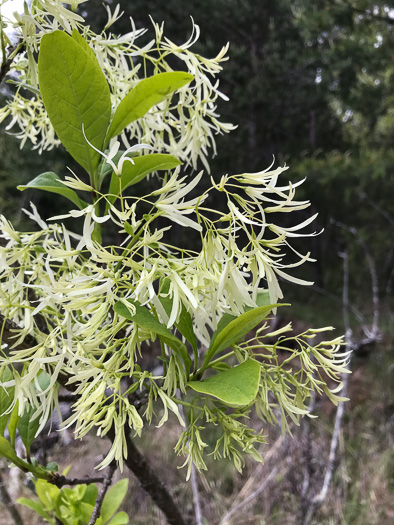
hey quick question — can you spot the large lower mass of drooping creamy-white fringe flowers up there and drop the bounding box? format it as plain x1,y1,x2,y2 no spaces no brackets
0,164,344,468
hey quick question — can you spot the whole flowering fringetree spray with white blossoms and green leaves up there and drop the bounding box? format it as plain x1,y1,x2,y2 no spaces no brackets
0,0,347,520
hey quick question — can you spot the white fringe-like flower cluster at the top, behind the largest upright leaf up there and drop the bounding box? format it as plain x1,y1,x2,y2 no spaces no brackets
0,0,234,171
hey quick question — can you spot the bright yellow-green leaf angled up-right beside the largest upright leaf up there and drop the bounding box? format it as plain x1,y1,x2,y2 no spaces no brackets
106,71,194,141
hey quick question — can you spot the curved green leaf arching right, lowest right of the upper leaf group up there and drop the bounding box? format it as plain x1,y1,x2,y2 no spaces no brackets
108,153,182,204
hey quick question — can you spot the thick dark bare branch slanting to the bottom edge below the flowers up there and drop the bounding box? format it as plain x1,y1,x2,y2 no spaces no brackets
107,427,187,525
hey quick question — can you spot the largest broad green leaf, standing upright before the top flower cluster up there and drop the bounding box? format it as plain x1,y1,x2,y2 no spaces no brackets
38,31,111,176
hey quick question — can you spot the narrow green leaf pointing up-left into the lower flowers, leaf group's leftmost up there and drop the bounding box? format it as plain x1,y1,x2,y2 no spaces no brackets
114,299,191,371
